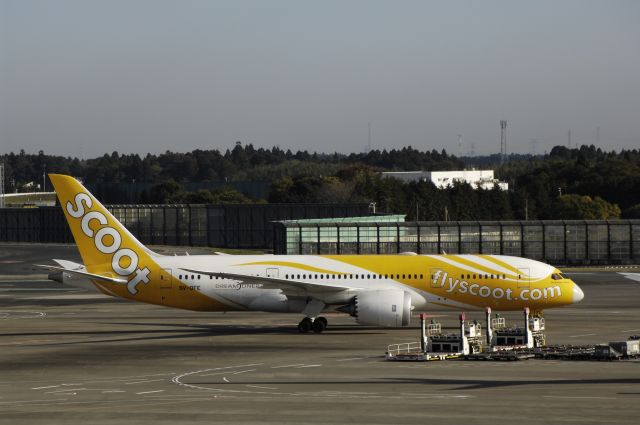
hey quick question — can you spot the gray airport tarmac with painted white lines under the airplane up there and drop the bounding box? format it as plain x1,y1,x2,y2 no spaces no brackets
0,245,640,424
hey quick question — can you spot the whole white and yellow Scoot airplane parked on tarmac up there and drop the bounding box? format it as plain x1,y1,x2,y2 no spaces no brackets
38,174,584,332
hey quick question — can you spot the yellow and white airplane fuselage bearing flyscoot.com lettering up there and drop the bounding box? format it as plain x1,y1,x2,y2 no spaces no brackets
85,255,576,312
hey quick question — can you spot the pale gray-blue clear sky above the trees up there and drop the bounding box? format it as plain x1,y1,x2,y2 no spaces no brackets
0,0,640,158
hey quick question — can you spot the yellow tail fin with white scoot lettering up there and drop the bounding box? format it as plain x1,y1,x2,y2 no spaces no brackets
49,174,159,295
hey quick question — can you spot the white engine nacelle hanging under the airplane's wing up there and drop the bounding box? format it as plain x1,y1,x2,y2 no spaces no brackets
343,289,411,328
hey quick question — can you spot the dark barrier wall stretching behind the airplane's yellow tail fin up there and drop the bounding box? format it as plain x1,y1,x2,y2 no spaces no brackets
0,204,369,249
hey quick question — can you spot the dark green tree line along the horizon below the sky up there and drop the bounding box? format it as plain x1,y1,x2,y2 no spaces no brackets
0,143,640,220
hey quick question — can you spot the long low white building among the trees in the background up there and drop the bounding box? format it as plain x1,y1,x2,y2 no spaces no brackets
382,170,509,190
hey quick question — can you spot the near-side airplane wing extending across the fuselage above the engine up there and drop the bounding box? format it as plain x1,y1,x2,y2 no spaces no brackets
183,269,362,295
